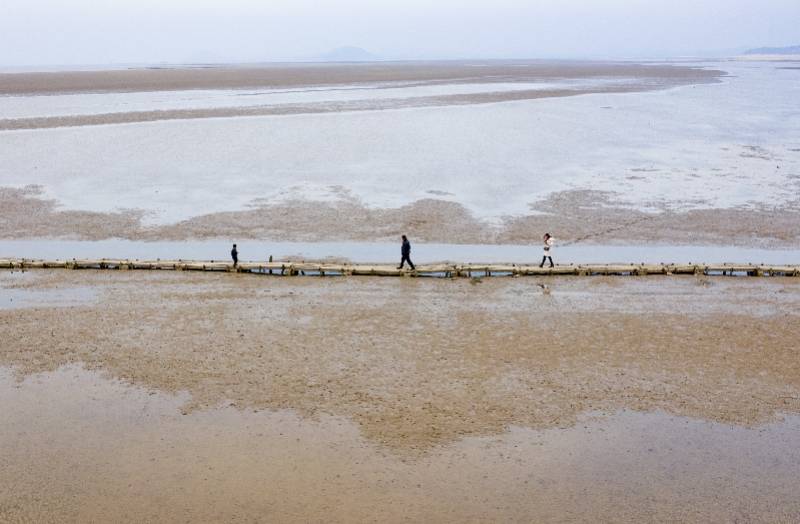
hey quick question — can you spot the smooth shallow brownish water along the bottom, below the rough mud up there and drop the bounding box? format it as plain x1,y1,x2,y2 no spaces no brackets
0,367,800,522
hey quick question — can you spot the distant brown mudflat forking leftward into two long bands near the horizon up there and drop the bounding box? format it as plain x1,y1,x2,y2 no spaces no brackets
0,61,723,131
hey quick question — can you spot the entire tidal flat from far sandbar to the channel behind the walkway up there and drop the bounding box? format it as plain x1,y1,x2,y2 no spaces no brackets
0,61,800,249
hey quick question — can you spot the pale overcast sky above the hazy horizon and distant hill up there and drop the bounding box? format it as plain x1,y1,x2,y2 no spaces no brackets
0,0,800,66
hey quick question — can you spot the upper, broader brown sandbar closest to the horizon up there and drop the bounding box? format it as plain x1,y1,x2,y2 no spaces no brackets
0,60,723,95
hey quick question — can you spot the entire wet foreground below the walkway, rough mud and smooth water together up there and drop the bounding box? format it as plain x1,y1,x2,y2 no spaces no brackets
0,271,800,522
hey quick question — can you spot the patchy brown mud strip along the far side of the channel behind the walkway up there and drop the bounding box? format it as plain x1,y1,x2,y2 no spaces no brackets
0,186,800,247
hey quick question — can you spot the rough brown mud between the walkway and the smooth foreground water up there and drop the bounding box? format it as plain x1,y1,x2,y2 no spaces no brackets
0,270,800,454
